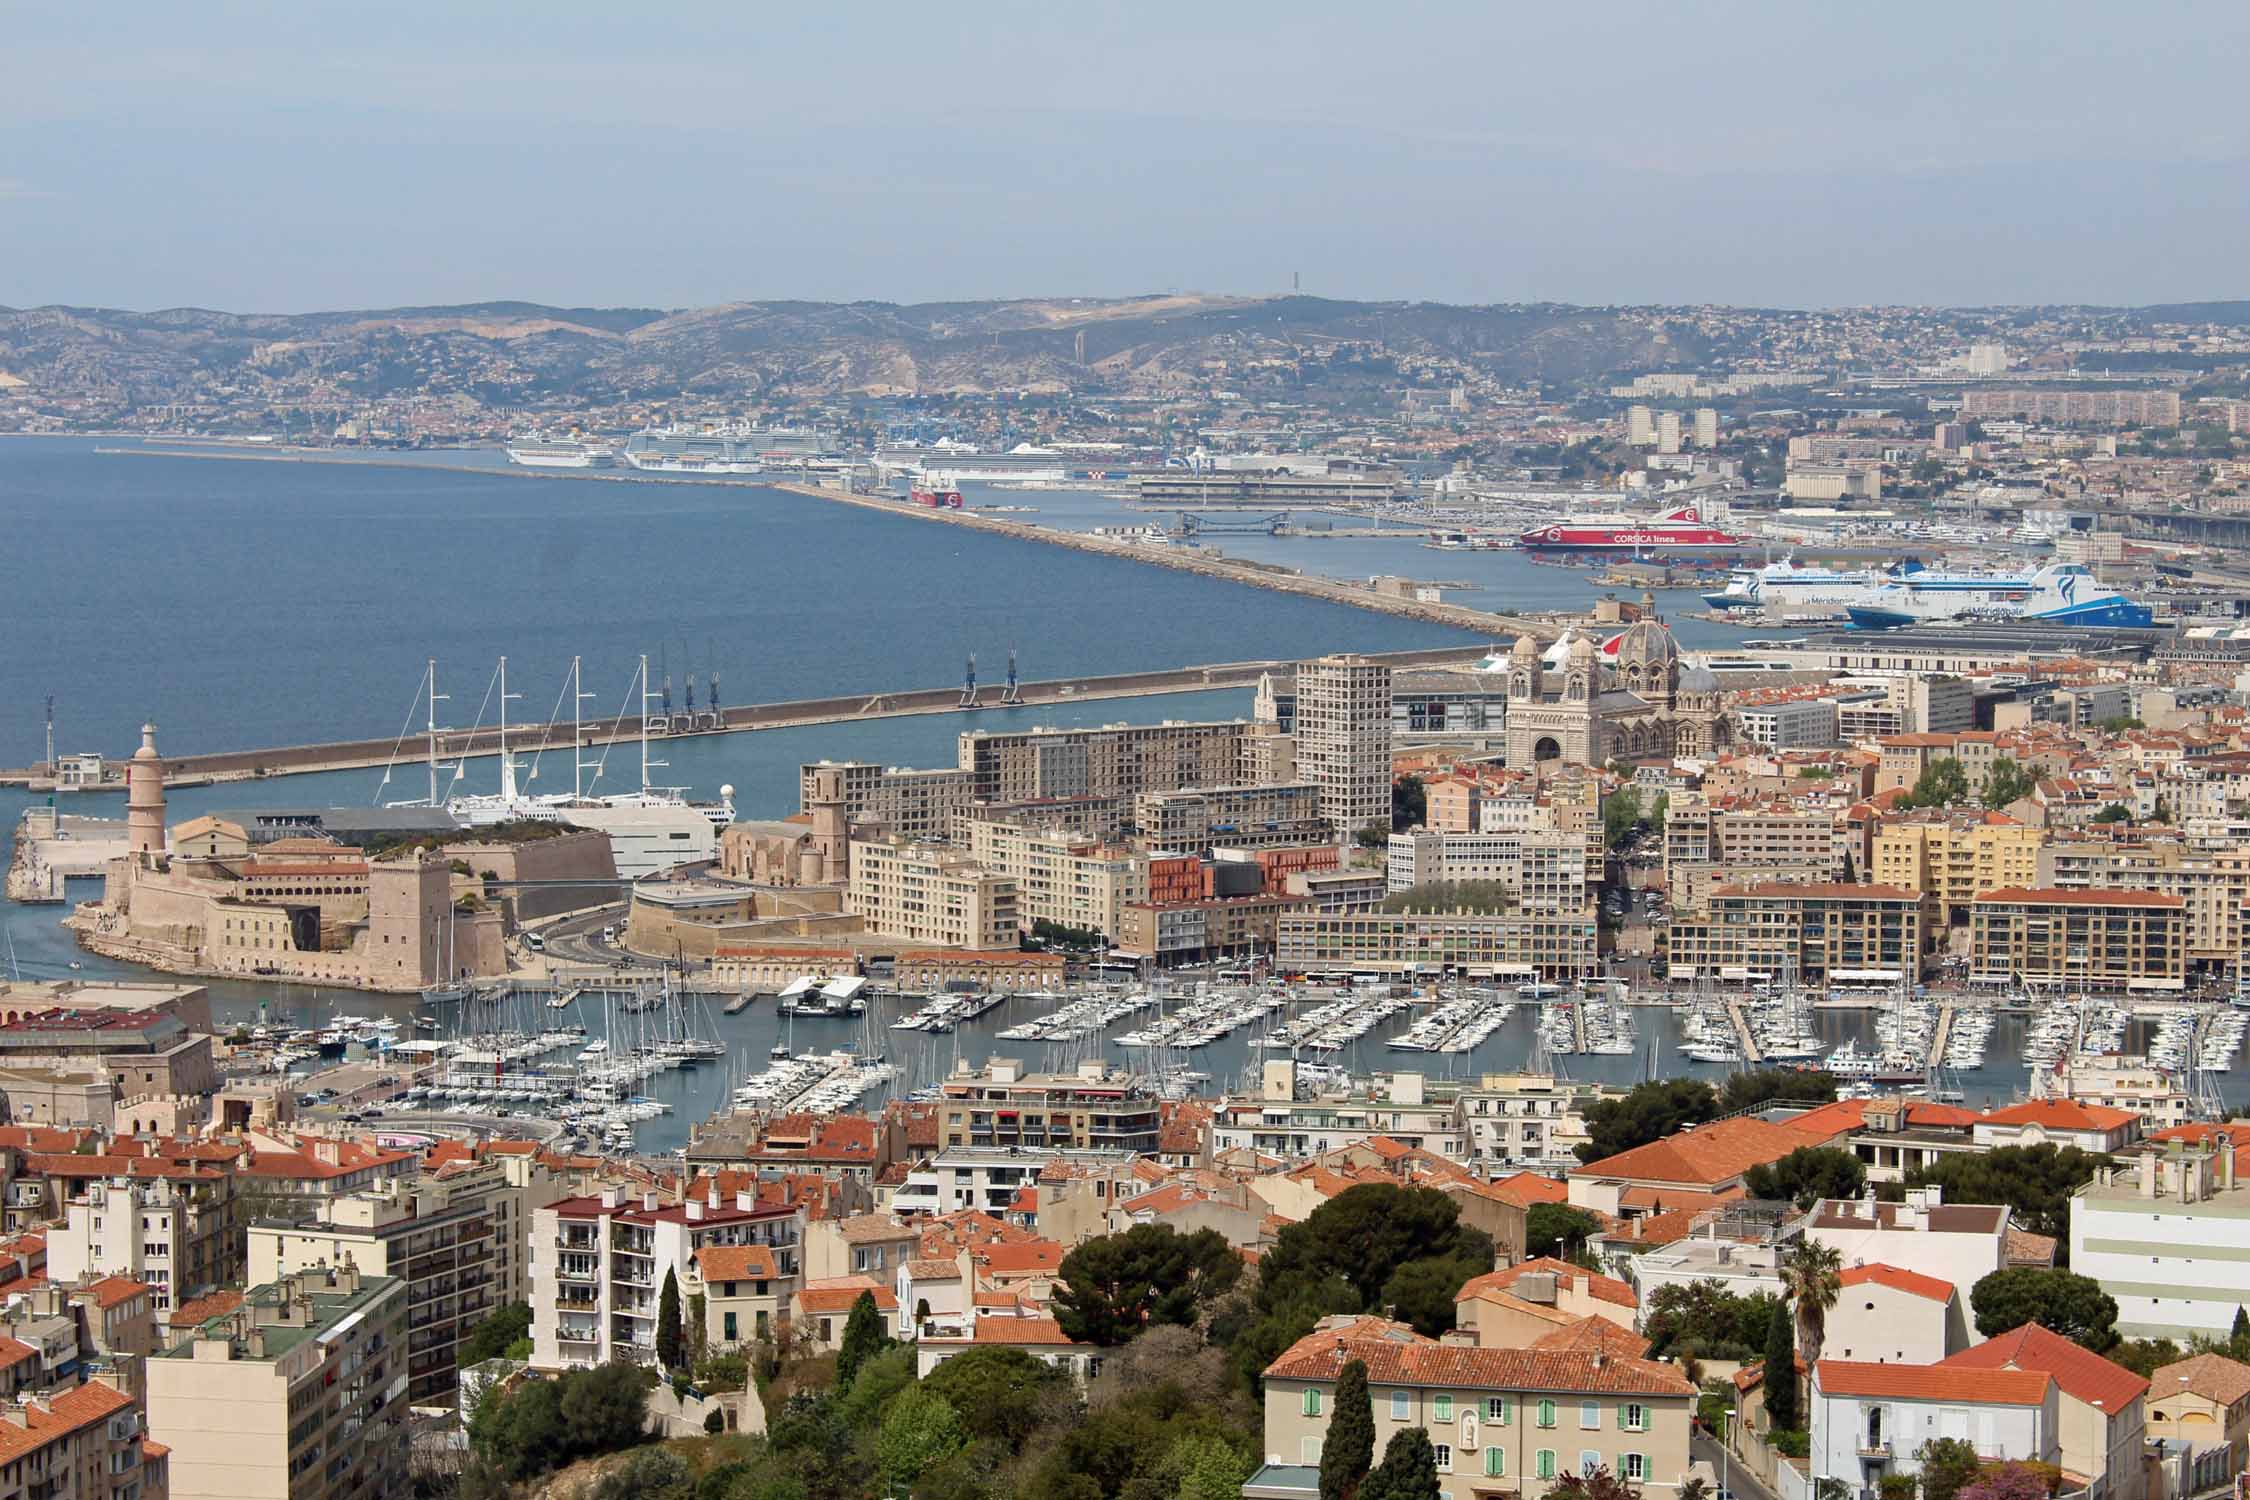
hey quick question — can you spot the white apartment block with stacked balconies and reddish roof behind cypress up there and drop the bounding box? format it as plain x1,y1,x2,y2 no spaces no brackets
531,1187,806,1370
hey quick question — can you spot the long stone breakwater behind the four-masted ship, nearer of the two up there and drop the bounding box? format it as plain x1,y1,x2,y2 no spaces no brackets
0,645,1492,791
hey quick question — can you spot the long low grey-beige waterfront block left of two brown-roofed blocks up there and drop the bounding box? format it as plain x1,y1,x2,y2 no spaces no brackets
1274,911,1600,981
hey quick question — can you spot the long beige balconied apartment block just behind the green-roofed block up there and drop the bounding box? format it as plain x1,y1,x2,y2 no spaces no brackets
250,1156,563,1406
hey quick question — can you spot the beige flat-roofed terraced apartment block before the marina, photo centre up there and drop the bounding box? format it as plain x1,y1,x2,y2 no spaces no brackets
938,1057,1163,1154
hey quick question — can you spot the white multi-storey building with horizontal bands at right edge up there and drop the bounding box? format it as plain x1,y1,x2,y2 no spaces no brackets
2070,1131,2250,1343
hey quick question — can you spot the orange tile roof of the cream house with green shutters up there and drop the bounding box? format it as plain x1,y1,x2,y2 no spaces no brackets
1265,1322,1694,1397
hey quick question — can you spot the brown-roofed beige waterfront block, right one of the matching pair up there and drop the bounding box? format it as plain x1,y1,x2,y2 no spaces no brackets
1969,886,2187,992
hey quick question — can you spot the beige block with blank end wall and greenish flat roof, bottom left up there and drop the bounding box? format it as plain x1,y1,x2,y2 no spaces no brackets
144,1266,407,1500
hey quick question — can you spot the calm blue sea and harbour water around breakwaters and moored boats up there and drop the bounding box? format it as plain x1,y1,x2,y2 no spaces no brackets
0,439,2214,1151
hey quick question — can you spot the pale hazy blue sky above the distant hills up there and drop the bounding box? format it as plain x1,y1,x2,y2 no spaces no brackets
0,0,2250,310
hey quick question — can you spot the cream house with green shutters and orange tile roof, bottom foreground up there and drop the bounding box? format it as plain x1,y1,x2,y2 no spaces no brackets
1244,1318,1697,1498
